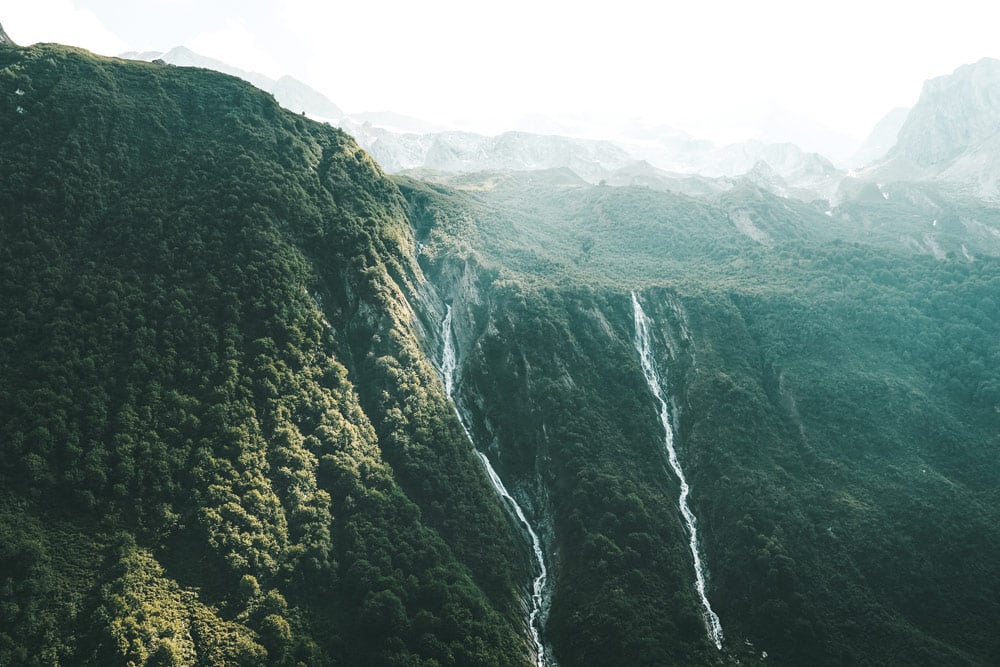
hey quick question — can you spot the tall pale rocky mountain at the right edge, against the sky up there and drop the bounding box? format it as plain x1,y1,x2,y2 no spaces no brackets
864,58,1000,199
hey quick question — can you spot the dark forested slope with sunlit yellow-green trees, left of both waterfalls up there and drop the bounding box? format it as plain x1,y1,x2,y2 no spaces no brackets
0,40,530,665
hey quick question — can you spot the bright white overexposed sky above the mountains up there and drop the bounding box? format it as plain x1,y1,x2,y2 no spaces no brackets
0,0,1000,154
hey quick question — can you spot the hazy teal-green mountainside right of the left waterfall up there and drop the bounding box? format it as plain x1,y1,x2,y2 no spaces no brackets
399,175,1000,665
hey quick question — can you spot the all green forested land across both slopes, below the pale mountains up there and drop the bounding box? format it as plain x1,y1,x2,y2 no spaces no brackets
0,37,1000,667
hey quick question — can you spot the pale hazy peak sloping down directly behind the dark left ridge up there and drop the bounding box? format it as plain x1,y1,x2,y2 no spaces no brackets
120,46,344,120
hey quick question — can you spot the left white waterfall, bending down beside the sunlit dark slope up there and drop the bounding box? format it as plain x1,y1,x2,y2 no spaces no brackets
441,306,555,667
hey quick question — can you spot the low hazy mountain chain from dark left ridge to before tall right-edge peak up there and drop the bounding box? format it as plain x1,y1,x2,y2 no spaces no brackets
122,47,843,200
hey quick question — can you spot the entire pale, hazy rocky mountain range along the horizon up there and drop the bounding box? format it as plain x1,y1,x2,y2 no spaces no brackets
119,47,1000,203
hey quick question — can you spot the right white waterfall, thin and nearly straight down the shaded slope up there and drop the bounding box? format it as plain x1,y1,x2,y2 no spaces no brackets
632,292,722,651
